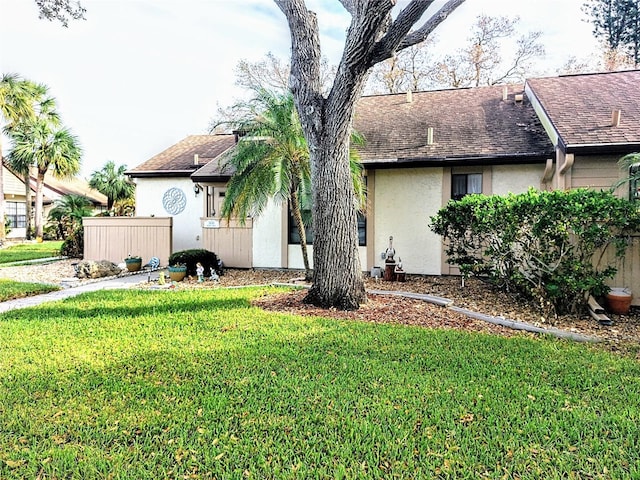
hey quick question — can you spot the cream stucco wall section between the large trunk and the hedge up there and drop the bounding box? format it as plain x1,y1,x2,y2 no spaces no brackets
370,168,443,275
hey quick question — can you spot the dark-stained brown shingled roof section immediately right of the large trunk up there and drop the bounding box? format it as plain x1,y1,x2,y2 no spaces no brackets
354,85,553,168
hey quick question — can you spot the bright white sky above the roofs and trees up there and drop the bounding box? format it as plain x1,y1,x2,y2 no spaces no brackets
0,0,598,178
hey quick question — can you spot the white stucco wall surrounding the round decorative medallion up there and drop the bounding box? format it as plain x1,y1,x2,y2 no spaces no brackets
136,177,203,252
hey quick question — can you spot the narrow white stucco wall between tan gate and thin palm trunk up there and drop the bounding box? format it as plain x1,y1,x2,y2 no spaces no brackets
253,201,286,268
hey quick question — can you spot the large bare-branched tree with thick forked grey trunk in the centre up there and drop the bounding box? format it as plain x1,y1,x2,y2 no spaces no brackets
274,0,464,309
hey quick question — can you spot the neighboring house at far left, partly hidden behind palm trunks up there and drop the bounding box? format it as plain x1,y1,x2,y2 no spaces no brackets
2,166,107,239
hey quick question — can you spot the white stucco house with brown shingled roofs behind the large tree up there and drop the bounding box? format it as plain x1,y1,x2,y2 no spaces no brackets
128,71,640,274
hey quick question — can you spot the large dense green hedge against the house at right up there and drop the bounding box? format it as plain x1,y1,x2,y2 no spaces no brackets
431,189,640,313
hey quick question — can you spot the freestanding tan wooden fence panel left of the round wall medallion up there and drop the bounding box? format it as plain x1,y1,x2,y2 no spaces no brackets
82,217,173,265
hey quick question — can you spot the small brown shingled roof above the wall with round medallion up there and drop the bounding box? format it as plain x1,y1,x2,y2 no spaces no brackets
127,135,235,177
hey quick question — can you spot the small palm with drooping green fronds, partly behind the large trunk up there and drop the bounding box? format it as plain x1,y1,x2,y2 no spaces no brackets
221,90,364,279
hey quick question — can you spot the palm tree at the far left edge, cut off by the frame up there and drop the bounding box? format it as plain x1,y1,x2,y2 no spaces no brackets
0,73,34,242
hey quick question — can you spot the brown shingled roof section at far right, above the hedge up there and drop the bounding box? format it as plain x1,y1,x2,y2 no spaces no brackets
527,70,640,151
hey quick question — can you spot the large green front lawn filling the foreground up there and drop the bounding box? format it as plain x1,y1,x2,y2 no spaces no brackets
0,288,640,479
